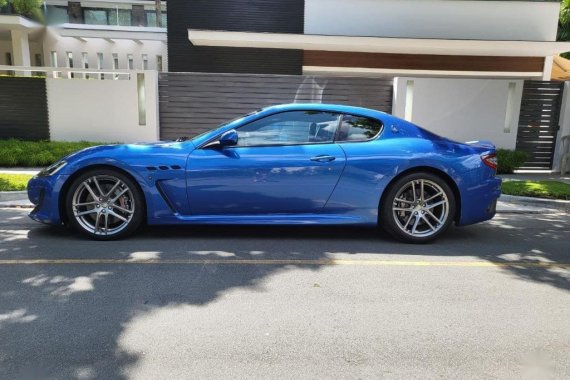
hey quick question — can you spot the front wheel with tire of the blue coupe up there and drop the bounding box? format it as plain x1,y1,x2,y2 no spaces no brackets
65,169,145,240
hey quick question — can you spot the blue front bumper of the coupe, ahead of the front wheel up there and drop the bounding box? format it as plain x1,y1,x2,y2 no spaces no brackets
28,175,69,224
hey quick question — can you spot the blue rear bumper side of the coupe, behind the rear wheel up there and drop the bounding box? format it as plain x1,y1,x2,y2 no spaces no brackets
457,177,502,226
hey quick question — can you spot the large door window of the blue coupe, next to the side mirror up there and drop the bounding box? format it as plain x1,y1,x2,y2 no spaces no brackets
237,111,340,146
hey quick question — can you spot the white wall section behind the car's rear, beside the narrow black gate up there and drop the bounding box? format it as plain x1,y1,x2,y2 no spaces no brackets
393,78,523,149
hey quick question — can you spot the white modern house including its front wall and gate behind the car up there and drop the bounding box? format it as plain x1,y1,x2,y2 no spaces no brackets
0,0,570,170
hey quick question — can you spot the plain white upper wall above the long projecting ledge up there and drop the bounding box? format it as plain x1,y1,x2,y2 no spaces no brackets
305,0,560,41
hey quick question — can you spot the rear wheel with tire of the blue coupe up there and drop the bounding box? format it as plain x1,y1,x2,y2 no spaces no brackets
379,172,455,244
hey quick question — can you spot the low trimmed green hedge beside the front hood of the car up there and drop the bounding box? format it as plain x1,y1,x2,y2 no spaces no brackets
0,140,102,167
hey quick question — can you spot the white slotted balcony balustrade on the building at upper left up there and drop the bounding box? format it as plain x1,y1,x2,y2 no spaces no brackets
44,36,168,71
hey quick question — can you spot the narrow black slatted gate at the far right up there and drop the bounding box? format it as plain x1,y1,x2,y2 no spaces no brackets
516,81,564,170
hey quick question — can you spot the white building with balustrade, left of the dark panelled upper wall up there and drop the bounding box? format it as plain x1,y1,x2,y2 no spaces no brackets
0,0,168,71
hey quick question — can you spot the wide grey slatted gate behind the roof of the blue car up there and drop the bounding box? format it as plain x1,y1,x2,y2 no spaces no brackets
158,73,393,140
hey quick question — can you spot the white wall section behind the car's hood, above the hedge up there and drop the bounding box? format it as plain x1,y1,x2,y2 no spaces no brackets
47,71,159,142
